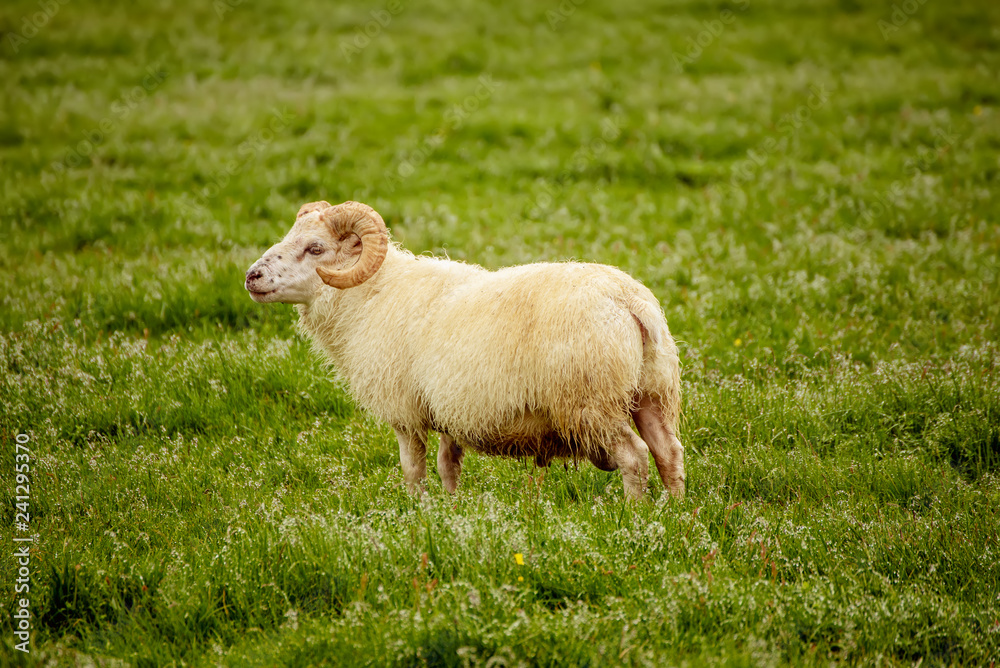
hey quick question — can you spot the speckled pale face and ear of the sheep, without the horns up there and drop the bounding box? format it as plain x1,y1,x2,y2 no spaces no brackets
245,205,361,304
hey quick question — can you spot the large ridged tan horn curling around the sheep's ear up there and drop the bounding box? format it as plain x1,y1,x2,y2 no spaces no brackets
314,202,389,290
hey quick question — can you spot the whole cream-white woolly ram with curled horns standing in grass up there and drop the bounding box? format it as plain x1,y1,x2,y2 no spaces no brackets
246,202,684,498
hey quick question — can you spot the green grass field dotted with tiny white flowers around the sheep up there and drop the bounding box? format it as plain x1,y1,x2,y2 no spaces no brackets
0,0,1000,666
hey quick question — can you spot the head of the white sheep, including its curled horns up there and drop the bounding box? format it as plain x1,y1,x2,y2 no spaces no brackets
245,202,389,304
